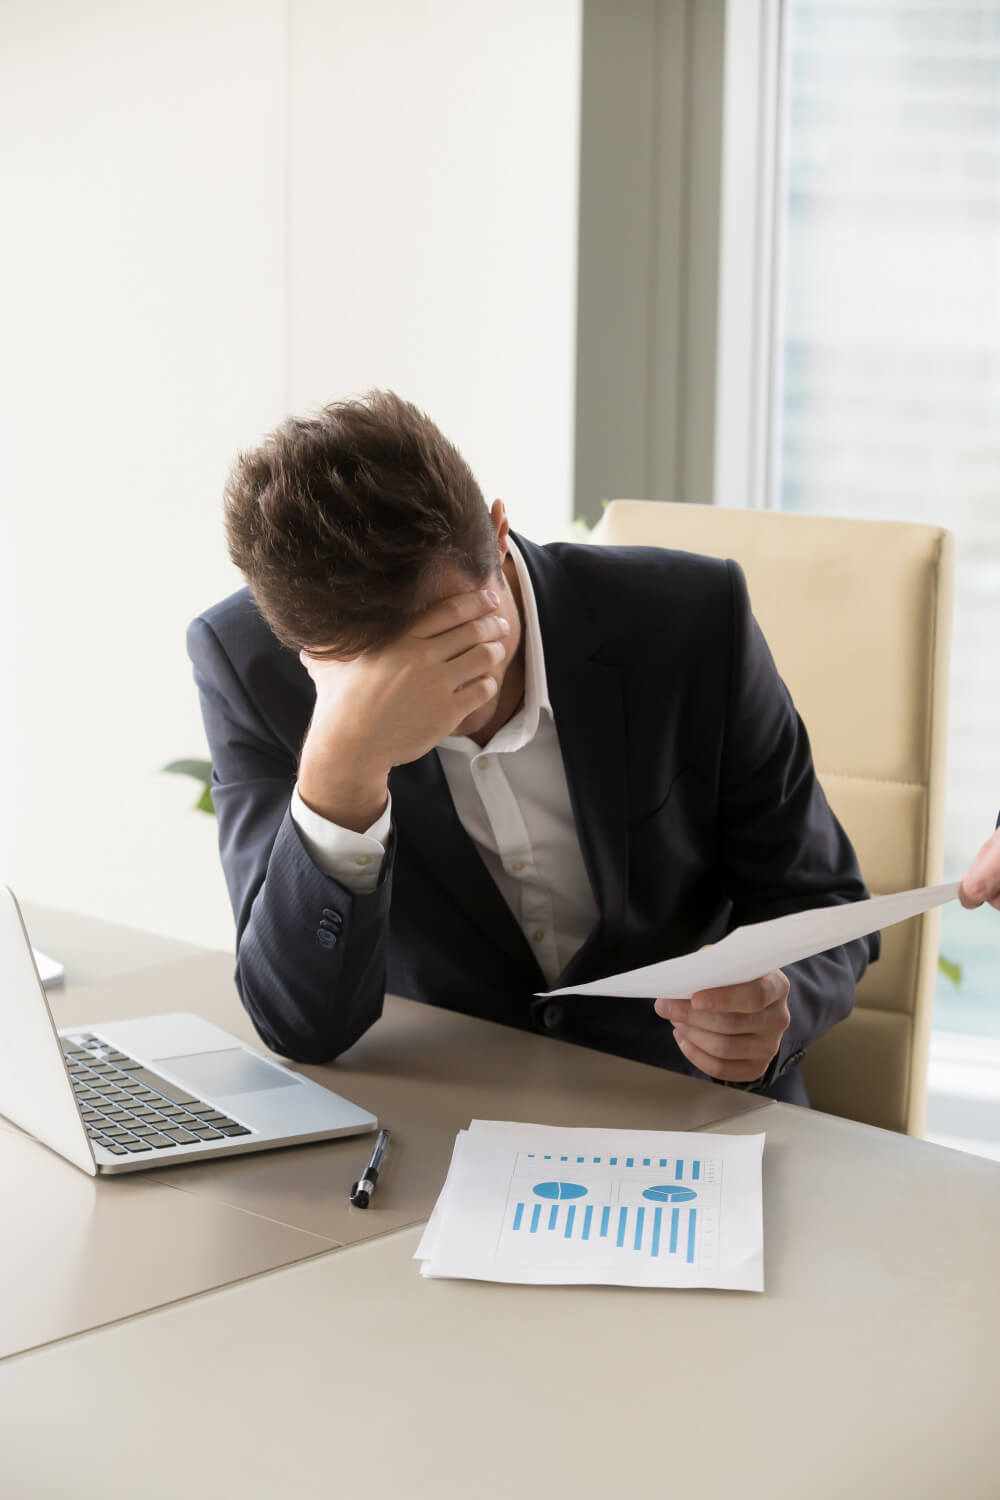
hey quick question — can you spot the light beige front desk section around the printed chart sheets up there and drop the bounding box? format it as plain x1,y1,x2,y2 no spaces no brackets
0,1104,1000,1500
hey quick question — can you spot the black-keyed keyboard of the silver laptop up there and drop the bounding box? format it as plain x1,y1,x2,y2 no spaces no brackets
60,1035,252,1157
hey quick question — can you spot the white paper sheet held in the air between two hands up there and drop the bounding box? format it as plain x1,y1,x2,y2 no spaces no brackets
544,881,958,1001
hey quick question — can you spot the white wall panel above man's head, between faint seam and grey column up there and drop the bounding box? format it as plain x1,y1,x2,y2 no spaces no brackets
289,0,580,542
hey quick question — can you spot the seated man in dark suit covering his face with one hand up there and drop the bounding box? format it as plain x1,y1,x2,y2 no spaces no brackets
189,392,877,1103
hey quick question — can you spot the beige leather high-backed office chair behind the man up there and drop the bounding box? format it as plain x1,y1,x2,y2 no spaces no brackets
594,500,952,1134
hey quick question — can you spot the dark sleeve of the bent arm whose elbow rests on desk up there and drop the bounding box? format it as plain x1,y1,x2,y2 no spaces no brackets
187,618,393,1062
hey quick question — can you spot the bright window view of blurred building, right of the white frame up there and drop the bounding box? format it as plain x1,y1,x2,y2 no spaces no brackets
769,0,1000,1158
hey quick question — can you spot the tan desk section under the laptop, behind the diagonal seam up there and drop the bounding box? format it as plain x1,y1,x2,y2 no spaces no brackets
0,908,765,1356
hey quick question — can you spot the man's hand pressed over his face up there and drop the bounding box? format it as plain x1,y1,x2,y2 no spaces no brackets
298,590,510,831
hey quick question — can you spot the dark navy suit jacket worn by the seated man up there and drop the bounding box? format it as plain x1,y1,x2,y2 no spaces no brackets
187,539,879,1103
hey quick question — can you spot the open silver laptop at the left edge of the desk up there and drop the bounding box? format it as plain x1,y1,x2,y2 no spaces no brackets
0,885,378,1176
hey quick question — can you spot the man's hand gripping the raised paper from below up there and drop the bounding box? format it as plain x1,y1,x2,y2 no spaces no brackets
654,969,792,1083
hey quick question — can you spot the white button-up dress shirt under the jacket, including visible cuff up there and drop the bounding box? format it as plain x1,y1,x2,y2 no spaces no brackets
291,543,598,984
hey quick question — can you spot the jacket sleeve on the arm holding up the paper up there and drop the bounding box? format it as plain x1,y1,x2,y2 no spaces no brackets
721,563,880,1088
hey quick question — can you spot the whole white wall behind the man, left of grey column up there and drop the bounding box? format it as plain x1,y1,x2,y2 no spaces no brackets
0,0,579,945
